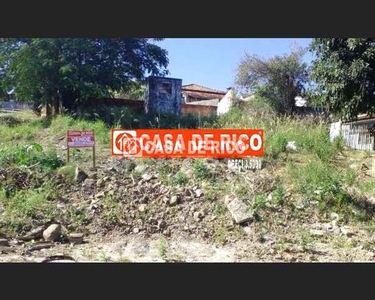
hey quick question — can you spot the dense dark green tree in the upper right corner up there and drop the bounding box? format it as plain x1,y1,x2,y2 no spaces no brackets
310,38,375,119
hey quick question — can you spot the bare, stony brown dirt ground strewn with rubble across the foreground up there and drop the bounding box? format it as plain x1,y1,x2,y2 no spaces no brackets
0,110,375,263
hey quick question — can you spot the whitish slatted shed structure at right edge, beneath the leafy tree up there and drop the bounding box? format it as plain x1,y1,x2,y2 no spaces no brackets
330,114,375,151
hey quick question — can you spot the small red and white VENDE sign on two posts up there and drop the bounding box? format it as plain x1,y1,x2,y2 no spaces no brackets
66,130,95,168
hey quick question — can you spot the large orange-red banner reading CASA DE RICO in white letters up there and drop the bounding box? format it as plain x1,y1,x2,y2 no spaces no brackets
112,129,264,158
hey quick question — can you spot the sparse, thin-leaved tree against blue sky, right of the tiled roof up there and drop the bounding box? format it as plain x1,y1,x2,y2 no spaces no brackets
235,48,307,114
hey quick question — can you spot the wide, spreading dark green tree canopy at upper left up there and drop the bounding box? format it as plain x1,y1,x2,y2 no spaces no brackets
0,38,168,116
